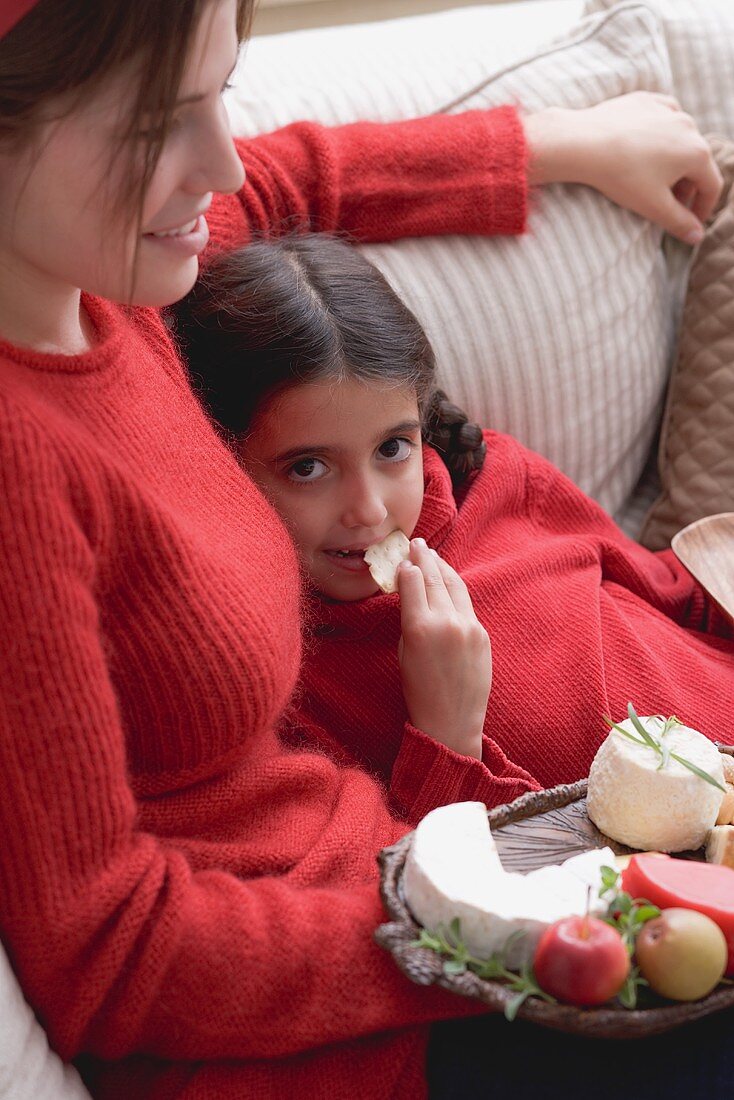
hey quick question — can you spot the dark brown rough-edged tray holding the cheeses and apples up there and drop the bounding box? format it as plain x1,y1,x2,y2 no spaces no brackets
375,745,734,1038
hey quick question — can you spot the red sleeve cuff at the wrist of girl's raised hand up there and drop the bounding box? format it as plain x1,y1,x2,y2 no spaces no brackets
390,722,539,825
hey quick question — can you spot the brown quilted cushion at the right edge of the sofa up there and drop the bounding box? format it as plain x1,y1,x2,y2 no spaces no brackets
642,139,734,550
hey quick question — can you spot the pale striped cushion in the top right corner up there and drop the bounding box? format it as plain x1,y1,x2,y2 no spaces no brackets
587,0,734,138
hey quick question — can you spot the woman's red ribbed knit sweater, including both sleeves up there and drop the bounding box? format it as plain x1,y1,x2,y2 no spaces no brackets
0,110,525,1100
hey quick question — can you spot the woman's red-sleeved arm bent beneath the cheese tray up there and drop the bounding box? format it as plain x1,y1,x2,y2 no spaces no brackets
0,403,477,1059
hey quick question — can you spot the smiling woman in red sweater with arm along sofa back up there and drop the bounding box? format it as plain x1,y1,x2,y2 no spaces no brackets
0,0,717,1100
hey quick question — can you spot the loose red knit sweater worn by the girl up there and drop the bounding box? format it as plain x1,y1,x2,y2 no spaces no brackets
287,432,734,820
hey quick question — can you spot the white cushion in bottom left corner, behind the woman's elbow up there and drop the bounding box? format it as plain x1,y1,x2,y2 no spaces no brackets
0,946,89,1100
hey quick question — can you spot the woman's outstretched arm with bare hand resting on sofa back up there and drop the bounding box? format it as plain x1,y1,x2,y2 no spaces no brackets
209,92,722,254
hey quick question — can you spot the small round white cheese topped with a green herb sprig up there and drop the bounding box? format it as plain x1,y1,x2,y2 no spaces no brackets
587,716,723,851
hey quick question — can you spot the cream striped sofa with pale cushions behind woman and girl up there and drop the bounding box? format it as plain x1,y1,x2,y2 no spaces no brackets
0,0,734,1100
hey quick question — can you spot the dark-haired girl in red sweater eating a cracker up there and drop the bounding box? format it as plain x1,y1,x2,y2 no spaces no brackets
183,237,734,816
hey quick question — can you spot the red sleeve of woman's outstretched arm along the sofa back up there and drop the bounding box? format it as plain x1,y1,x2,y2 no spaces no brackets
209,108,527,248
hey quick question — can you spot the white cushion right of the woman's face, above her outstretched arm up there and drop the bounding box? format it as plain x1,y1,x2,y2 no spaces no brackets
227,0,583,136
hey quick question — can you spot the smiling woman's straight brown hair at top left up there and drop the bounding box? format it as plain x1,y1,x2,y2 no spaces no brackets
0,0,254,217
